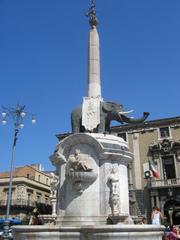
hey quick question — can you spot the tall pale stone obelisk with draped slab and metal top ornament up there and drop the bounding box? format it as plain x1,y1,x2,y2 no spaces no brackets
82,0,102,132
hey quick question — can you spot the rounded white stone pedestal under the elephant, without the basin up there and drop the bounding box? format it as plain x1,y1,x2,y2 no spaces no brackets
51,133,132,226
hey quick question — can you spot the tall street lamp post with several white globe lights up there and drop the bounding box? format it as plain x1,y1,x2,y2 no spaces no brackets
2,104,36,239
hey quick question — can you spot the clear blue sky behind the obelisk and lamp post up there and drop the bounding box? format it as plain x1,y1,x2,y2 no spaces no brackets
0,0,180,171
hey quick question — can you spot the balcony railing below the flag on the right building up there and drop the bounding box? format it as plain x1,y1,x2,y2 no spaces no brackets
148,178,180,188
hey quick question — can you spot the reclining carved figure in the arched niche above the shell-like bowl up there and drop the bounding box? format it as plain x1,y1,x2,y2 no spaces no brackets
68,149,92,171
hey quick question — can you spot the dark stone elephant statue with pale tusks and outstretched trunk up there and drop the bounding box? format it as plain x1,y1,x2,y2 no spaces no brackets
71,101,149,133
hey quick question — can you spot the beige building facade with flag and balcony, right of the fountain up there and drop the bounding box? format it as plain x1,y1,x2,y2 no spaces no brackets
111,117,180,224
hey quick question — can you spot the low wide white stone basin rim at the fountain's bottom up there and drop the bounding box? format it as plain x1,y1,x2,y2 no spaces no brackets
13,224,164,240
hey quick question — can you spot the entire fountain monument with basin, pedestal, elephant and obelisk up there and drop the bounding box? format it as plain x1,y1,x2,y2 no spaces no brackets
14,0,164,240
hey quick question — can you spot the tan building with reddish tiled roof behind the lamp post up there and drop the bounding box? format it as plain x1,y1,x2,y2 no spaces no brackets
0,165,52,222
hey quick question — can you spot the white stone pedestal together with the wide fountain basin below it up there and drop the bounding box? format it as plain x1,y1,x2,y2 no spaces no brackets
13,133,164,240
